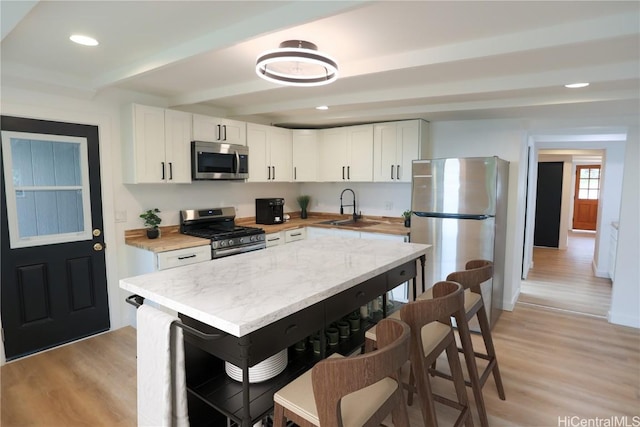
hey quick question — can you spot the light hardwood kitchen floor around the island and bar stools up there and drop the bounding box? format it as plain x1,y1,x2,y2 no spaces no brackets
0,239,640,427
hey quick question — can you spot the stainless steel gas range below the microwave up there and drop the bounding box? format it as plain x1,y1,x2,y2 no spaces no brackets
180,207,266,258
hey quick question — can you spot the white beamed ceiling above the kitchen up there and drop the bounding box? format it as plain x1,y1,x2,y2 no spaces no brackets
0,0,640,127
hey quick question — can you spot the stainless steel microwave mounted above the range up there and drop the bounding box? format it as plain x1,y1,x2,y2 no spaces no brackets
191,141,249,180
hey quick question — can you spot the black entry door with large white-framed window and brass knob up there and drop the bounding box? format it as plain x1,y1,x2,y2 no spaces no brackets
0,116,109,360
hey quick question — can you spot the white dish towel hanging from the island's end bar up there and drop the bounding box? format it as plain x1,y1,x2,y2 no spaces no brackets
136,304,189,427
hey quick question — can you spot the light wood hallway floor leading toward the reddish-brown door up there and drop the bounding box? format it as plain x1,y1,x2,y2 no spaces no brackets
518,231,611,318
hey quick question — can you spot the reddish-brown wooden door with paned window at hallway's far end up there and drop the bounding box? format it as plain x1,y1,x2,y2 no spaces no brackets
573,165,600,230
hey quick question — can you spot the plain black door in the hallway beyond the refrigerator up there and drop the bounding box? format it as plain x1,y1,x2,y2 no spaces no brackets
533,162,563,248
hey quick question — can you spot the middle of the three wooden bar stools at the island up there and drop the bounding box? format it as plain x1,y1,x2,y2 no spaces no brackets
402,282,473,427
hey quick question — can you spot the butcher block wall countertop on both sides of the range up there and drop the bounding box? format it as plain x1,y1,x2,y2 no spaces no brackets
124,212,409,253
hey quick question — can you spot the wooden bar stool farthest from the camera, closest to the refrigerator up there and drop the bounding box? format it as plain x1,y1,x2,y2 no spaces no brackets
416,260,505,427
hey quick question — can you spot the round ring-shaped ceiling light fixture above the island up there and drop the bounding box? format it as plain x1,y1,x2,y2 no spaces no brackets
256,40,338,86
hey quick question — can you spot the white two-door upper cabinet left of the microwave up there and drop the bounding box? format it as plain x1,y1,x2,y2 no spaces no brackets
122,104,192,184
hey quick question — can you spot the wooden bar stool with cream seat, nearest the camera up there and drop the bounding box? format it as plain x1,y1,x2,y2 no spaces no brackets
273,319,410,427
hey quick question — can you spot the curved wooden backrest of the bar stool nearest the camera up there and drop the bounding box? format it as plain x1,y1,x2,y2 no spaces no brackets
312,319,410,427
